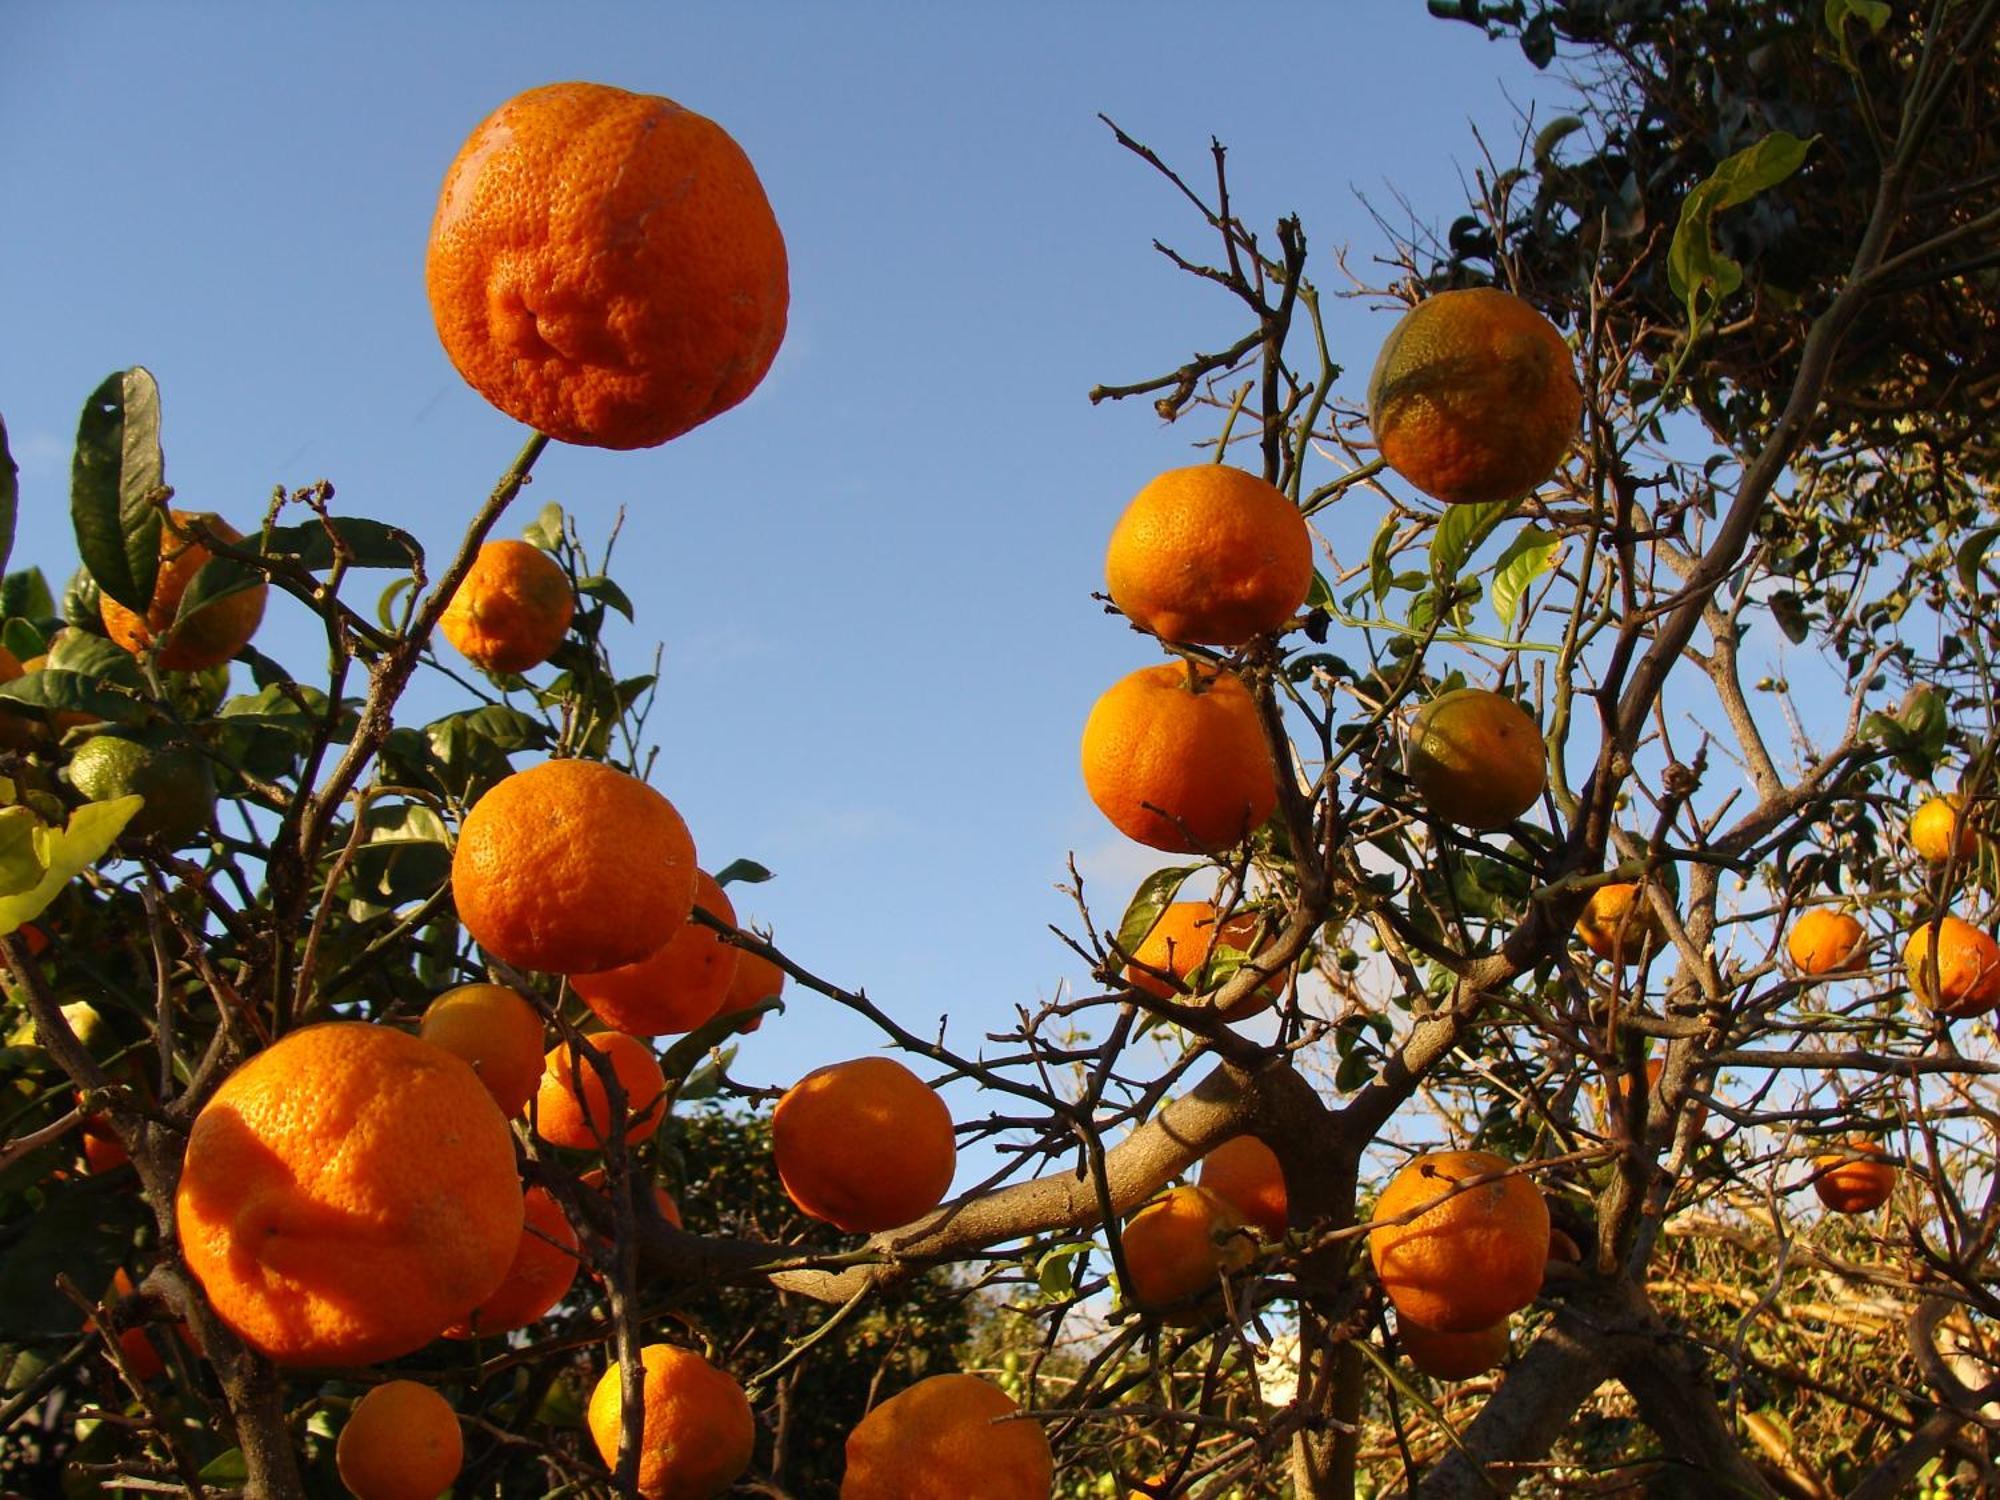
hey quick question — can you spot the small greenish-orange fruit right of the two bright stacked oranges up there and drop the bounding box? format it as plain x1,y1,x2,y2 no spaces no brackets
1404,688,1548,828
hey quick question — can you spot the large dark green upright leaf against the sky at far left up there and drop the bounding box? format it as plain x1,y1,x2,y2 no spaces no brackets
70,366,166,614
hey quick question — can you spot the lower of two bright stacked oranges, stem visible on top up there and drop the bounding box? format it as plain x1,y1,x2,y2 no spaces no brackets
1082,662,1278,854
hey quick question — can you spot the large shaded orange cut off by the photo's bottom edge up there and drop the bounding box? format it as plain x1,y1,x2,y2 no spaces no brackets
840,1374,1056,1500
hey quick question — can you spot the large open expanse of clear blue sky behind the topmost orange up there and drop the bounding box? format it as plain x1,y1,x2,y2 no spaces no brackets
0,0,1560,1128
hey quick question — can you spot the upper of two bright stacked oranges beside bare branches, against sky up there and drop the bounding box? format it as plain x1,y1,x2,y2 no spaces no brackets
1104,464,1312,646
